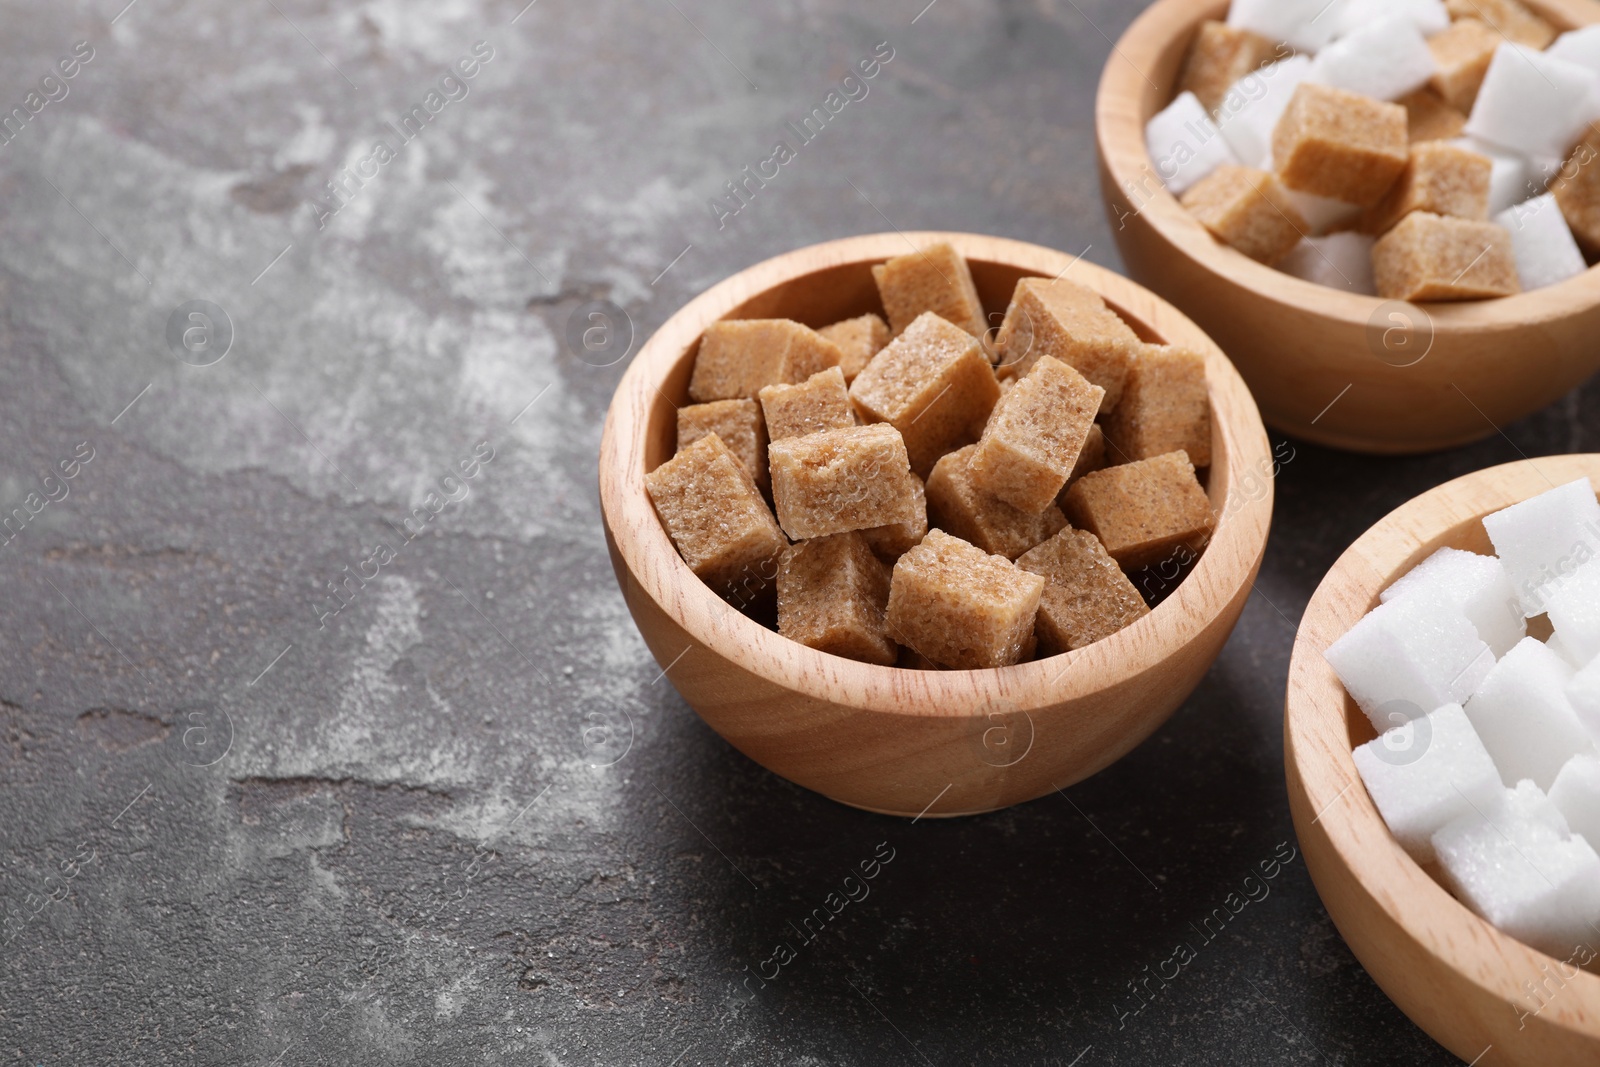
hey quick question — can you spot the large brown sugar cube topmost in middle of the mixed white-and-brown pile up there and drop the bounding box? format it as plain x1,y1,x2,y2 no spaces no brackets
1272,82,1410,208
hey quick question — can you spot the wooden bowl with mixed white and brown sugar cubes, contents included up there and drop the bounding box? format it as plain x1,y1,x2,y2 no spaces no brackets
1096,0,1600,454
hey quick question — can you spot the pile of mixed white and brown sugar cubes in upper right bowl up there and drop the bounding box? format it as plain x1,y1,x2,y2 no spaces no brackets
1128,0,1600,301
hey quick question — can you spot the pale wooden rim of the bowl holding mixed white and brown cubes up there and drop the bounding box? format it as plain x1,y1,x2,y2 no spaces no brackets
1094,0,1600,331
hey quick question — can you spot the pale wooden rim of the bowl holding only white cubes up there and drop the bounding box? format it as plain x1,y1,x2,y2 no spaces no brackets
1283,453,1600,1038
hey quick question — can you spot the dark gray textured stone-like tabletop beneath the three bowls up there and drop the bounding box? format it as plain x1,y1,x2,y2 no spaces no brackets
0,0,1595,1067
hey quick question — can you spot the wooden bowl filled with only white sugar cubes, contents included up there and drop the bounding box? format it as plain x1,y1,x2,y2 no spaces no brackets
1285,454,1600,1067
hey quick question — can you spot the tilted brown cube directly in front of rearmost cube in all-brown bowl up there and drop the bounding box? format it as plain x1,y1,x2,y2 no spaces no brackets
850,312,1000,477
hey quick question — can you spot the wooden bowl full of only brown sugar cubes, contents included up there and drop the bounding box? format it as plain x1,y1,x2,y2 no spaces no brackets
600,234,1275,816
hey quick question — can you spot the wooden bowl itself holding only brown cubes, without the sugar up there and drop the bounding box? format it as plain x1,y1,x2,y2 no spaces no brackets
600,234,1272,816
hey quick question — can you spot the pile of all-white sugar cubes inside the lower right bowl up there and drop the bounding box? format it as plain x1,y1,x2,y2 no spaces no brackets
1325,478,1600,958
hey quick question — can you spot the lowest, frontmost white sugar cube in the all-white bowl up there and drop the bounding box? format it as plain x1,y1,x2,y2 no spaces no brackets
1434,783,1600,960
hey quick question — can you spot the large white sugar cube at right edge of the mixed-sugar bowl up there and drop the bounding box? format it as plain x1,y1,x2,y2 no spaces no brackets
1466,42,1595,158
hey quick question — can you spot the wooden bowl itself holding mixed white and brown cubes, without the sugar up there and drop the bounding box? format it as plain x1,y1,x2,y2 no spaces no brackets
1094,0,1600,453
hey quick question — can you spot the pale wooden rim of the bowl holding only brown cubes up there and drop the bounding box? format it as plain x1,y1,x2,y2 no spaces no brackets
600,230,1274,717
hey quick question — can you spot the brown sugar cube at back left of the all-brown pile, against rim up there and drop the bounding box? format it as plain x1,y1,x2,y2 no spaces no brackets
690,318,843,403
